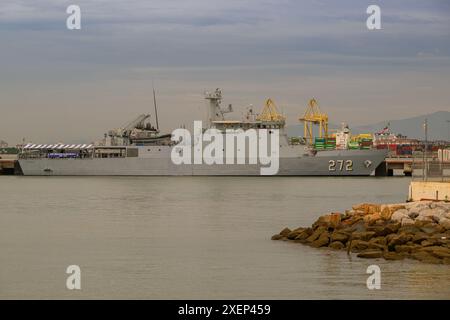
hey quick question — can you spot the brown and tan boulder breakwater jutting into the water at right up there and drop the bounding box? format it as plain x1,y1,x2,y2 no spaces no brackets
272,201,450,265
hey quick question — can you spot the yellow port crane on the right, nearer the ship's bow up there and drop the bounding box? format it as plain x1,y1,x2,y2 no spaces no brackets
299,98,328,144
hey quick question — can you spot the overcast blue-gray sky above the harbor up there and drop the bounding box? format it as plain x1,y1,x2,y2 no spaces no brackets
0,0,450,144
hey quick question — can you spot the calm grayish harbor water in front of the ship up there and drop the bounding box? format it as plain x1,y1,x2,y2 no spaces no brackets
0,176,450,299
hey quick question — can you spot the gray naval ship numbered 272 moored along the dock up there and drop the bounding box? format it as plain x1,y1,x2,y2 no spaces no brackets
15,89,386,176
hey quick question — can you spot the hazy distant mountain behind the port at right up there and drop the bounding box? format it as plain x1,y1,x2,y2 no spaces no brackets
287,111,450,141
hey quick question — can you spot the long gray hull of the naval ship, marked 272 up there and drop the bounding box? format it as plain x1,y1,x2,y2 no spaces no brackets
19,148,386,176
